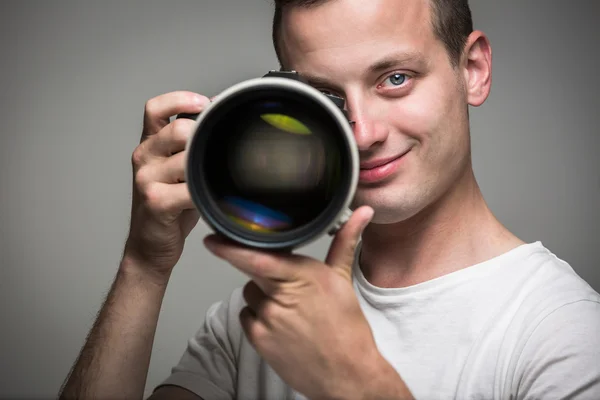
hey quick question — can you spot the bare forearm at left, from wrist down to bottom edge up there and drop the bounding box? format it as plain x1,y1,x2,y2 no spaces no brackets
60,258,168,399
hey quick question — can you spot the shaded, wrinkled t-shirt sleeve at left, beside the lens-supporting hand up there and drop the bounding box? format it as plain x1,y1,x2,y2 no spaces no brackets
155,289,244,400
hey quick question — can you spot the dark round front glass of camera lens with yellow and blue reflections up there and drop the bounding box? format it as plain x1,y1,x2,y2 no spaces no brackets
204,95,343,235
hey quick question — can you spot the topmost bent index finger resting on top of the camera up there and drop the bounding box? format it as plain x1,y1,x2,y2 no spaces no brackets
142,90,210,140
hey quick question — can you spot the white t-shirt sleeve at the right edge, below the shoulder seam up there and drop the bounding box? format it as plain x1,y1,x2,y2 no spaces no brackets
516,300,600,400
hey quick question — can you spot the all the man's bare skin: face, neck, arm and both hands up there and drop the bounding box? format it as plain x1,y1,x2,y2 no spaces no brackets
61,0,523,399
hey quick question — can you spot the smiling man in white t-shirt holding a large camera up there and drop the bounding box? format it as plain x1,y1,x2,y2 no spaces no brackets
62,0,600,400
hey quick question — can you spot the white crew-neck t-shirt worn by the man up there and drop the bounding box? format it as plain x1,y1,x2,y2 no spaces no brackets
156,242,600,400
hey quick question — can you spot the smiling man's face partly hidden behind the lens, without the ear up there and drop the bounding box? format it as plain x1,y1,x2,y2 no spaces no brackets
281,0,478,223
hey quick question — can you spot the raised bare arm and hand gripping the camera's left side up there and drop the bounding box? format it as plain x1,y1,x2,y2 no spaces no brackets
60,92,209,399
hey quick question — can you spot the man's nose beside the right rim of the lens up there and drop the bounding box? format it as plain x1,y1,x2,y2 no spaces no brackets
347,100,389,152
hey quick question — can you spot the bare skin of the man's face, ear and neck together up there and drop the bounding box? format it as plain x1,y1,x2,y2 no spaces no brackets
282,0,523,287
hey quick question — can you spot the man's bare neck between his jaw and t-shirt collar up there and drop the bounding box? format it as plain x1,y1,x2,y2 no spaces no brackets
360,165,523,287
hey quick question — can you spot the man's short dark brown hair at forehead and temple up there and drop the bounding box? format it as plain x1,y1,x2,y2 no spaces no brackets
273,0,473,66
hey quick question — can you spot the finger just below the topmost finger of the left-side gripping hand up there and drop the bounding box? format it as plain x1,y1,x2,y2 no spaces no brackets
142,118,196,157
